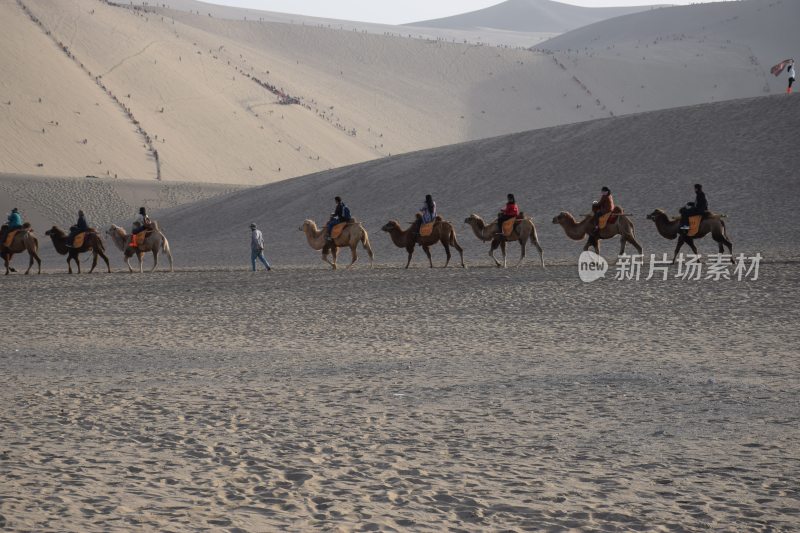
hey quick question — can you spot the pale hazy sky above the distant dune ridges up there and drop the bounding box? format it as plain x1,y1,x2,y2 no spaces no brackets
205,0,720,24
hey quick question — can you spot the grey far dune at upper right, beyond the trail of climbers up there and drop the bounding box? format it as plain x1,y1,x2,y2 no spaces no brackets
539,0,800,102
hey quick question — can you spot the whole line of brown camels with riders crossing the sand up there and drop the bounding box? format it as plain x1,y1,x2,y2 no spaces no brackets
0,185,733,275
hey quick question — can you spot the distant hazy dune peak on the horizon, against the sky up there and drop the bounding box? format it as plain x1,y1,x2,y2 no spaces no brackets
411,0,653,33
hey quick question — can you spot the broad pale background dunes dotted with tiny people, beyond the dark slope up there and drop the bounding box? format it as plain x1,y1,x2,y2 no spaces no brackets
0,0,796,184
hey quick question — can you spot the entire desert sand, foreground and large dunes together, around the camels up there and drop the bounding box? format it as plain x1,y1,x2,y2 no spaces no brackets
0,0,800,533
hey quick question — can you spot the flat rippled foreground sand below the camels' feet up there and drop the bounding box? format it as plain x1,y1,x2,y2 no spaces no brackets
0,263,800,531
